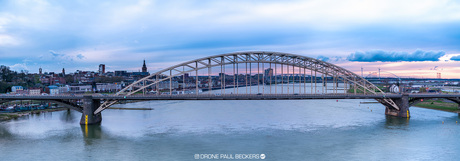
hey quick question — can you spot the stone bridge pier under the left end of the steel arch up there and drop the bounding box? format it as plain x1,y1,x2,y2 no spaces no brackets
80,96,102,125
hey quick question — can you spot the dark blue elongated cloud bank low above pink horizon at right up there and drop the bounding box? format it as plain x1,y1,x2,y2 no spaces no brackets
347,50,446,62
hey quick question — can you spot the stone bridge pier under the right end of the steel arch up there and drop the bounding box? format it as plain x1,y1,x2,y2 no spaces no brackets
385,94,410,118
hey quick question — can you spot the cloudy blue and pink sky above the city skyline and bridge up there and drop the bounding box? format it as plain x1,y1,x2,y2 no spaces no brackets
0,0,460,78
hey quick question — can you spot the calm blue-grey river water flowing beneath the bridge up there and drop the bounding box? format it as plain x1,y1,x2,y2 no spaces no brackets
0,85,460,161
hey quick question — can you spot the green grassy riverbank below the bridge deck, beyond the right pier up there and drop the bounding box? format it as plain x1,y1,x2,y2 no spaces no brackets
414,100,460,113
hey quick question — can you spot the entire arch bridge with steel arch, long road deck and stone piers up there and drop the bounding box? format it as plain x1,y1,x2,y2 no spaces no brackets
0,52,460,124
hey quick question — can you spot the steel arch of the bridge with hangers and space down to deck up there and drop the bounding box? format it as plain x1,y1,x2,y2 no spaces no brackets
93,51,402,123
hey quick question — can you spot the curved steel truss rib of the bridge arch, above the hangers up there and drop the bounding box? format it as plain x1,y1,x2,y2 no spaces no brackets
94,51,399,114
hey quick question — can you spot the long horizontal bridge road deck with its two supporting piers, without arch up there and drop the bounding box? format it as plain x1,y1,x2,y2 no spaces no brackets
0,93,460,124
